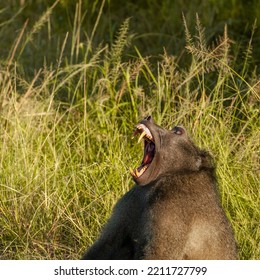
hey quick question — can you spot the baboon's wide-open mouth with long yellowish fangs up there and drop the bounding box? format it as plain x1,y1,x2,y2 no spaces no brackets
130,123,155,179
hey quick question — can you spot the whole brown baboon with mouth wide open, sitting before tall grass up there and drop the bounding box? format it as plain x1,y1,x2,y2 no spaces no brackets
82,116,237,260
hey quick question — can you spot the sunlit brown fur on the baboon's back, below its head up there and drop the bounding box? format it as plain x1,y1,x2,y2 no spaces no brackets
144,171,237,259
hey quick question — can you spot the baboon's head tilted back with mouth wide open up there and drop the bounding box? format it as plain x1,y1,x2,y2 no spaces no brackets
131,116,212,185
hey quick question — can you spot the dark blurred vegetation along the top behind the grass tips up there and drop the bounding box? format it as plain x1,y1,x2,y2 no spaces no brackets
0,0,260,74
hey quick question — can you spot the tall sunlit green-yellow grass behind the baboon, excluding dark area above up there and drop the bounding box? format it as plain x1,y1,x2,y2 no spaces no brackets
0,1,260,259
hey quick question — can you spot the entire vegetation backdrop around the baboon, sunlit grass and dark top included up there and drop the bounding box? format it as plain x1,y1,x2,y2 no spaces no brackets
0,0,260,259
